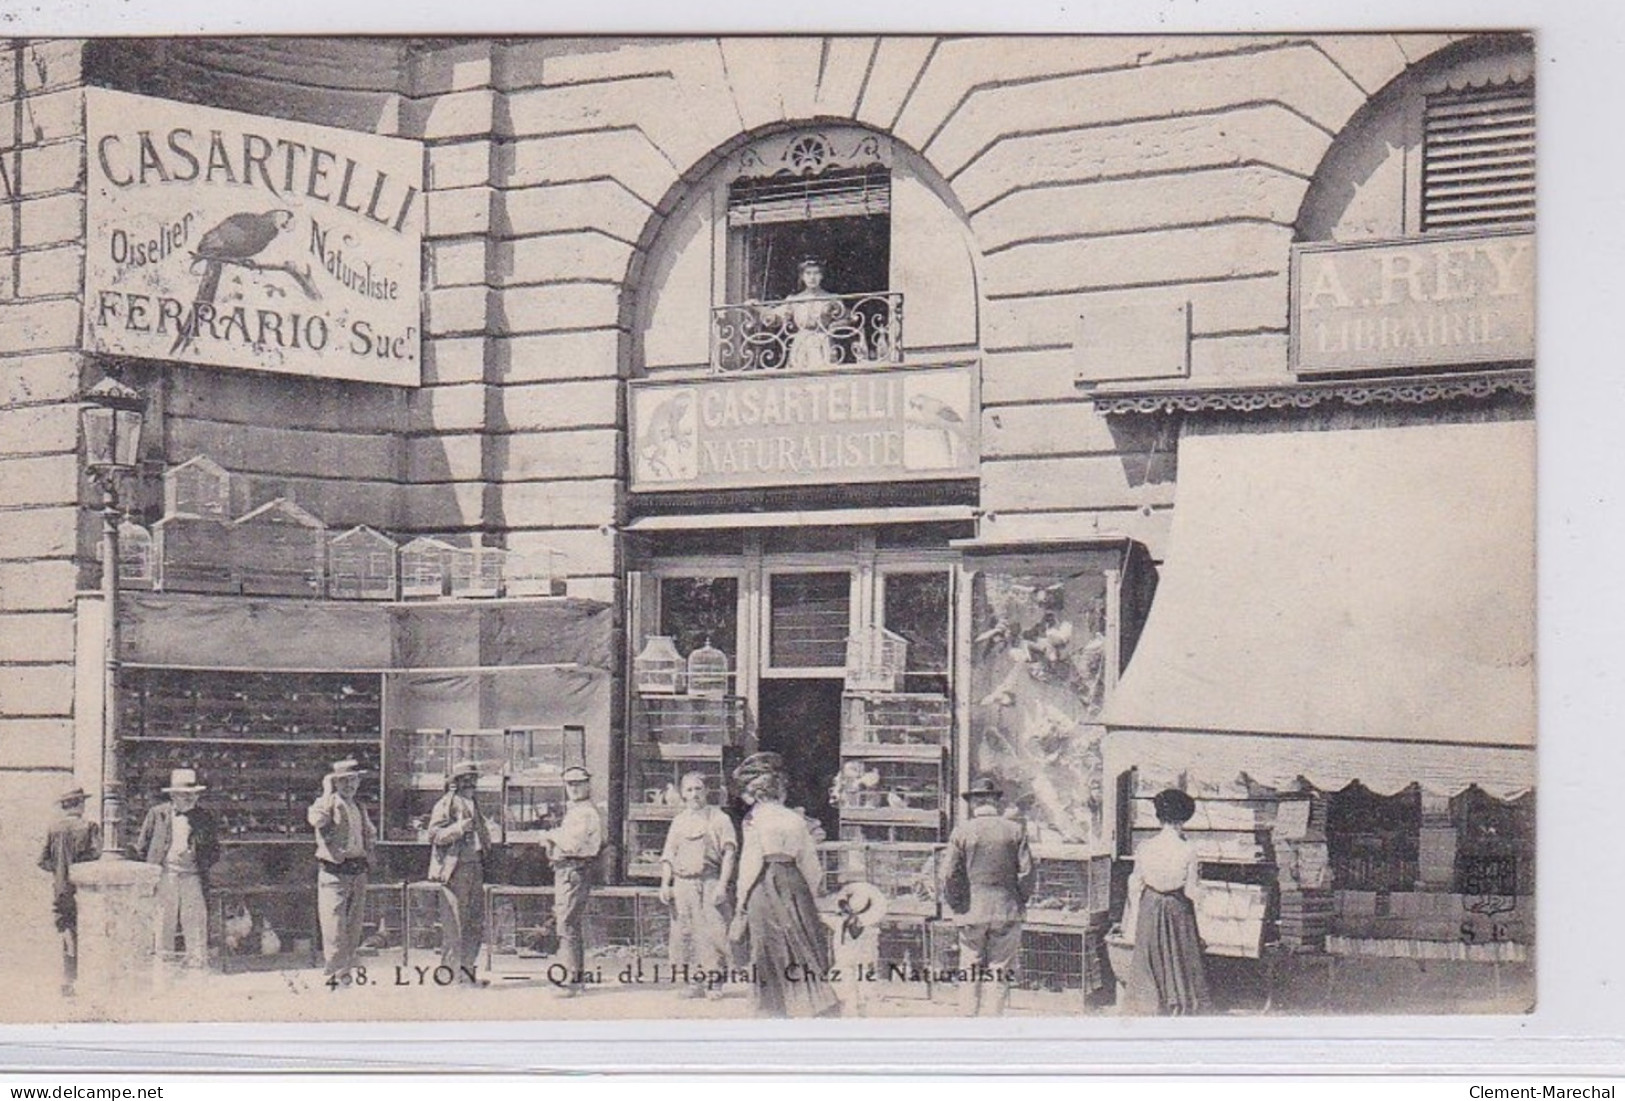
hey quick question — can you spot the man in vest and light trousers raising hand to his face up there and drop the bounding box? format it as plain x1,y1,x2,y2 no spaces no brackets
306,758,379,991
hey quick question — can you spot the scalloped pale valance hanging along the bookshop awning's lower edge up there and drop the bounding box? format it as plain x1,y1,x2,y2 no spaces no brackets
1102,731,1534,799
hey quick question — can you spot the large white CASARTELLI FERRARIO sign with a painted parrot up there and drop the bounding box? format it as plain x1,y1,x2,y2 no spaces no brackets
85,88,424,386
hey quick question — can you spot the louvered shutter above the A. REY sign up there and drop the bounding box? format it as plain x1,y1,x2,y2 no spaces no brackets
1422,81,1534,232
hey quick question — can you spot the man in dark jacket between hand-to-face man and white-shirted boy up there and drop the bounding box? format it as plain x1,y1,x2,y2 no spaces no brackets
429,762,491,974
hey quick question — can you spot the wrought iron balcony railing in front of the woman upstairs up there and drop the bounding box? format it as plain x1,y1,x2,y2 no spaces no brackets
712,292,904,375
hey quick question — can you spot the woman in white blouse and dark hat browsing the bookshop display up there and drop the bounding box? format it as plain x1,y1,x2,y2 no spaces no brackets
1125,789,1211,1015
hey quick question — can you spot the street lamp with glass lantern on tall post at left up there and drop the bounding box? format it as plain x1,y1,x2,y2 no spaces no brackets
80,377,146,859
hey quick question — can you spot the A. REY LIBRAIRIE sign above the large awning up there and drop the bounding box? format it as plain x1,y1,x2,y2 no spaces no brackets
1292,234,1534,373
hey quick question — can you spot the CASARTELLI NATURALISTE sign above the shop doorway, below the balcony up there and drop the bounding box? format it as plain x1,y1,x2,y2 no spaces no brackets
631,365,978,490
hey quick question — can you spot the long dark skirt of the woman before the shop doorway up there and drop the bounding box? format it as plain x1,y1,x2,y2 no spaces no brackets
744,861,840,1017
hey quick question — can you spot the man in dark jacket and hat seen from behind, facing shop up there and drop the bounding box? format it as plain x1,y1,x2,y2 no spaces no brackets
944,776,1034,1017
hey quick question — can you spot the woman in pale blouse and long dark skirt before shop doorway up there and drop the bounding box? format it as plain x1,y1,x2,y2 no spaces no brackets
728,753,840,1017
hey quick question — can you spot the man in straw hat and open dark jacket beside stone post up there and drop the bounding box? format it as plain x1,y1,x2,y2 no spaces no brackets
135,768,219,968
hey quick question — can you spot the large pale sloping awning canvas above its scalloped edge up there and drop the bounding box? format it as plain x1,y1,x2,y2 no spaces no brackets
1102,421,1536,750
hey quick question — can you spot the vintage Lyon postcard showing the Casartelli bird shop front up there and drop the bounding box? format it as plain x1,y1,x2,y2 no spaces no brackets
0,31,1537,1023
